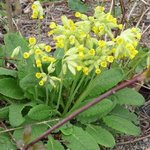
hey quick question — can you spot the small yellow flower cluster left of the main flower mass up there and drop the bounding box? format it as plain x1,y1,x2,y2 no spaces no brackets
23,37,60,87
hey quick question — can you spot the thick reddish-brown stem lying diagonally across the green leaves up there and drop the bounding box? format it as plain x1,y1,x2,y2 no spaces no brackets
22,71,142,150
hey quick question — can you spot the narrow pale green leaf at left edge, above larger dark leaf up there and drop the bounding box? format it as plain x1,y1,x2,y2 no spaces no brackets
0,67,17,77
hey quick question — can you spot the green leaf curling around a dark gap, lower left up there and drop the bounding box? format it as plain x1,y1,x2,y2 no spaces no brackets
9,103,34,127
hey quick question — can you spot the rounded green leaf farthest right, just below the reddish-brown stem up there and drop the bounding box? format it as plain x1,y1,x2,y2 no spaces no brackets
114,88,144,106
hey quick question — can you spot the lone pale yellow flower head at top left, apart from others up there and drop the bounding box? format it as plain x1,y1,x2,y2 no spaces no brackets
31,1,44,19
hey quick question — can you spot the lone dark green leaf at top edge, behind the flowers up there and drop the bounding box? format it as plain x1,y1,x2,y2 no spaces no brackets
68,0,88,13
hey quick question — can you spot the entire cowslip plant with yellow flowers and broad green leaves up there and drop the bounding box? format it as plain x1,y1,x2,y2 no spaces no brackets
0,2,147,150
